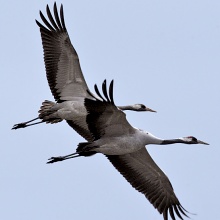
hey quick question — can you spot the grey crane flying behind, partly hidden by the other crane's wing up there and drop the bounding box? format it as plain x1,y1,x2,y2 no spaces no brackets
12,3,156,133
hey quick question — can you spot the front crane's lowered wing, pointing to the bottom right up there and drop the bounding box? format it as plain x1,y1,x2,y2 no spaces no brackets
106,148,187,220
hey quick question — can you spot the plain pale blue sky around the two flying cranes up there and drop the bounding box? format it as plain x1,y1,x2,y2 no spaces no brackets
0,0,220,220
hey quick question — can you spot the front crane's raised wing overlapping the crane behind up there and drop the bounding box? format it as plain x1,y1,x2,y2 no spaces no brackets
84,80,135,140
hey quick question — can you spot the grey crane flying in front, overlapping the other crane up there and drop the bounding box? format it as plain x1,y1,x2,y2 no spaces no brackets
48,81,208,220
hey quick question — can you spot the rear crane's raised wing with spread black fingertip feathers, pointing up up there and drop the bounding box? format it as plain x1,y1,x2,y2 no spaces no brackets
36,3,91,102
